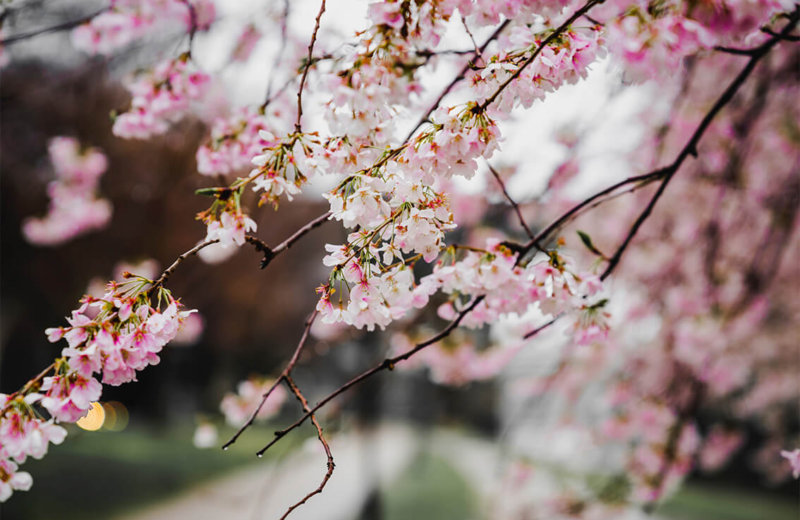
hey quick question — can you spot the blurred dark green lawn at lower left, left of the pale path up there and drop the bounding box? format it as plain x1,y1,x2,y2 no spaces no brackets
0,427,302,520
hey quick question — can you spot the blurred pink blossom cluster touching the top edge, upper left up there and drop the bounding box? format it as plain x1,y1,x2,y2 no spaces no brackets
72,0,216,55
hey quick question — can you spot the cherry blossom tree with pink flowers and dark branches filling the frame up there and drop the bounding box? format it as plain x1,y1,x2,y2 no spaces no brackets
0,0,800,518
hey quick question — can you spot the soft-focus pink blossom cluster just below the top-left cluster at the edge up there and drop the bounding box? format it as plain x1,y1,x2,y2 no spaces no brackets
112,55,210,139
